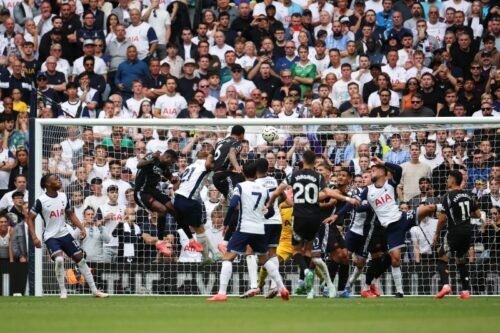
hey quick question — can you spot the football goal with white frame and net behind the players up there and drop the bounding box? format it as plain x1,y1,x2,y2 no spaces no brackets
30,118,500,295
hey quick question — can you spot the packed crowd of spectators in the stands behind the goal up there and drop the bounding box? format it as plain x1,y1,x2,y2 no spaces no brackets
0,0,500,294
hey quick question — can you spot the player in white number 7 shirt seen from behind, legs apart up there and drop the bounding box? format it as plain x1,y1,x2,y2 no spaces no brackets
208,163,289,302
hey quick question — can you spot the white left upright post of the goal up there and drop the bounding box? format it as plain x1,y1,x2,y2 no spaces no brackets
30,121,43,296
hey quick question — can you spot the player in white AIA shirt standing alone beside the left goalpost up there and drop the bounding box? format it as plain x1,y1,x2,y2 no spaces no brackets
27,173,108,299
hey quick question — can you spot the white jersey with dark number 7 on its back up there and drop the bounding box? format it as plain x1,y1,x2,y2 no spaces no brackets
233,181,268,235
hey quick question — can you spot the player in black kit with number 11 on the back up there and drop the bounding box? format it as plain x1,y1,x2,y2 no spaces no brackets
433,170,481,299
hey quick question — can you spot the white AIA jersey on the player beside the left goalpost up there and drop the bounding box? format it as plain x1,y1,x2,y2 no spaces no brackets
31,192,71,241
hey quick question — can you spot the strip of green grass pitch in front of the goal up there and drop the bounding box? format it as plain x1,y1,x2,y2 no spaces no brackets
0,296,500,333
